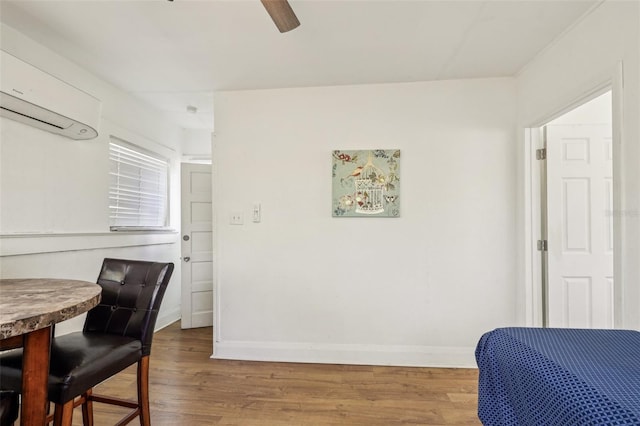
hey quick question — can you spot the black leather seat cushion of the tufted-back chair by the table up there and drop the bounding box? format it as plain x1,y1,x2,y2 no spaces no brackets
0,332,142,404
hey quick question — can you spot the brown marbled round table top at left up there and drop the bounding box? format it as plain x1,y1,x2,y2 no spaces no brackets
0,278,102,339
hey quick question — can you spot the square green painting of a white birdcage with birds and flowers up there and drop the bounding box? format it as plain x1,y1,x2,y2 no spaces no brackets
332,149,400,217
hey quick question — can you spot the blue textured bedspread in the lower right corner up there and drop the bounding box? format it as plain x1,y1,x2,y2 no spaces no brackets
476,328,640,426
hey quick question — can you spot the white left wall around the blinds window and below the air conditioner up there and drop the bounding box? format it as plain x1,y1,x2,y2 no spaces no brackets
0,24,182,333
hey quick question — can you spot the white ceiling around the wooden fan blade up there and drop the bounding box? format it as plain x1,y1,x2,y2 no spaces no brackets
0,0,601,129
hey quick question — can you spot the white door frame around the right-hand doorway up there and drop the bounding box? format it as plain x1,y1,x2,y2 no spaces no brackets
522,62,624,328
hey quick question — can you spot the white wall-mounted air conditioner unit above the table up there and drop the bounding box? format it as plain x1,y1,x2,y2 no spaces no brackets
0,51,102,139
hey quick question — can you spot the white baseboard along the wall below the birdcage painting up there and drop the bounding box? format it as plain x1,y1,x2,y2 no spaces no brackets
212,341,477,368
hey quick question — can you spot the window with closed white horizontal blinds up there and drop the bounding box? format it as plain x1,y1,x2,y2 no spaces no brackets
109,136,169,231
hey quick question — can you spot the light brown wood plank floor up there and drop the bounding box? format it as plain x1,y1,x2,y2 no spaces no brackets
74,323,480,426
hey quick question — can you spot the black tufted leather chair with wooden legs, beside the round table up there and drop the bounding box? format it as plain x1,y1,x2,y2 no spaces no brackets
0,259,173,425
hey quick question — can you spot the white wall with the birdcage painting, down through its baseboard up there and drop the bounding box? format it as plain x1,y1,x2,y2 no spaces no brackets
214,79,517,366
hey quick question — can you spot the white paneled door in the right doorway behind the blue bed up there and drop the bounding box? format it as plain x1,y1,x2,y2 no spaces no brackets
546,124,614,328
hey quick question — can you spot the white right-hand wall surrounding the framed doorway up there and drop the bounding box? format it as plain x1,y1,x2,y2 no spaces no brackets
517,1,640,329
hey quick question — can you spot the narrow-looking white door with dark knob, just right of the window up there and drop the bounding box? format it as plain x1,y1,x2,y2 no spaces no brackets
181,163,213,328
